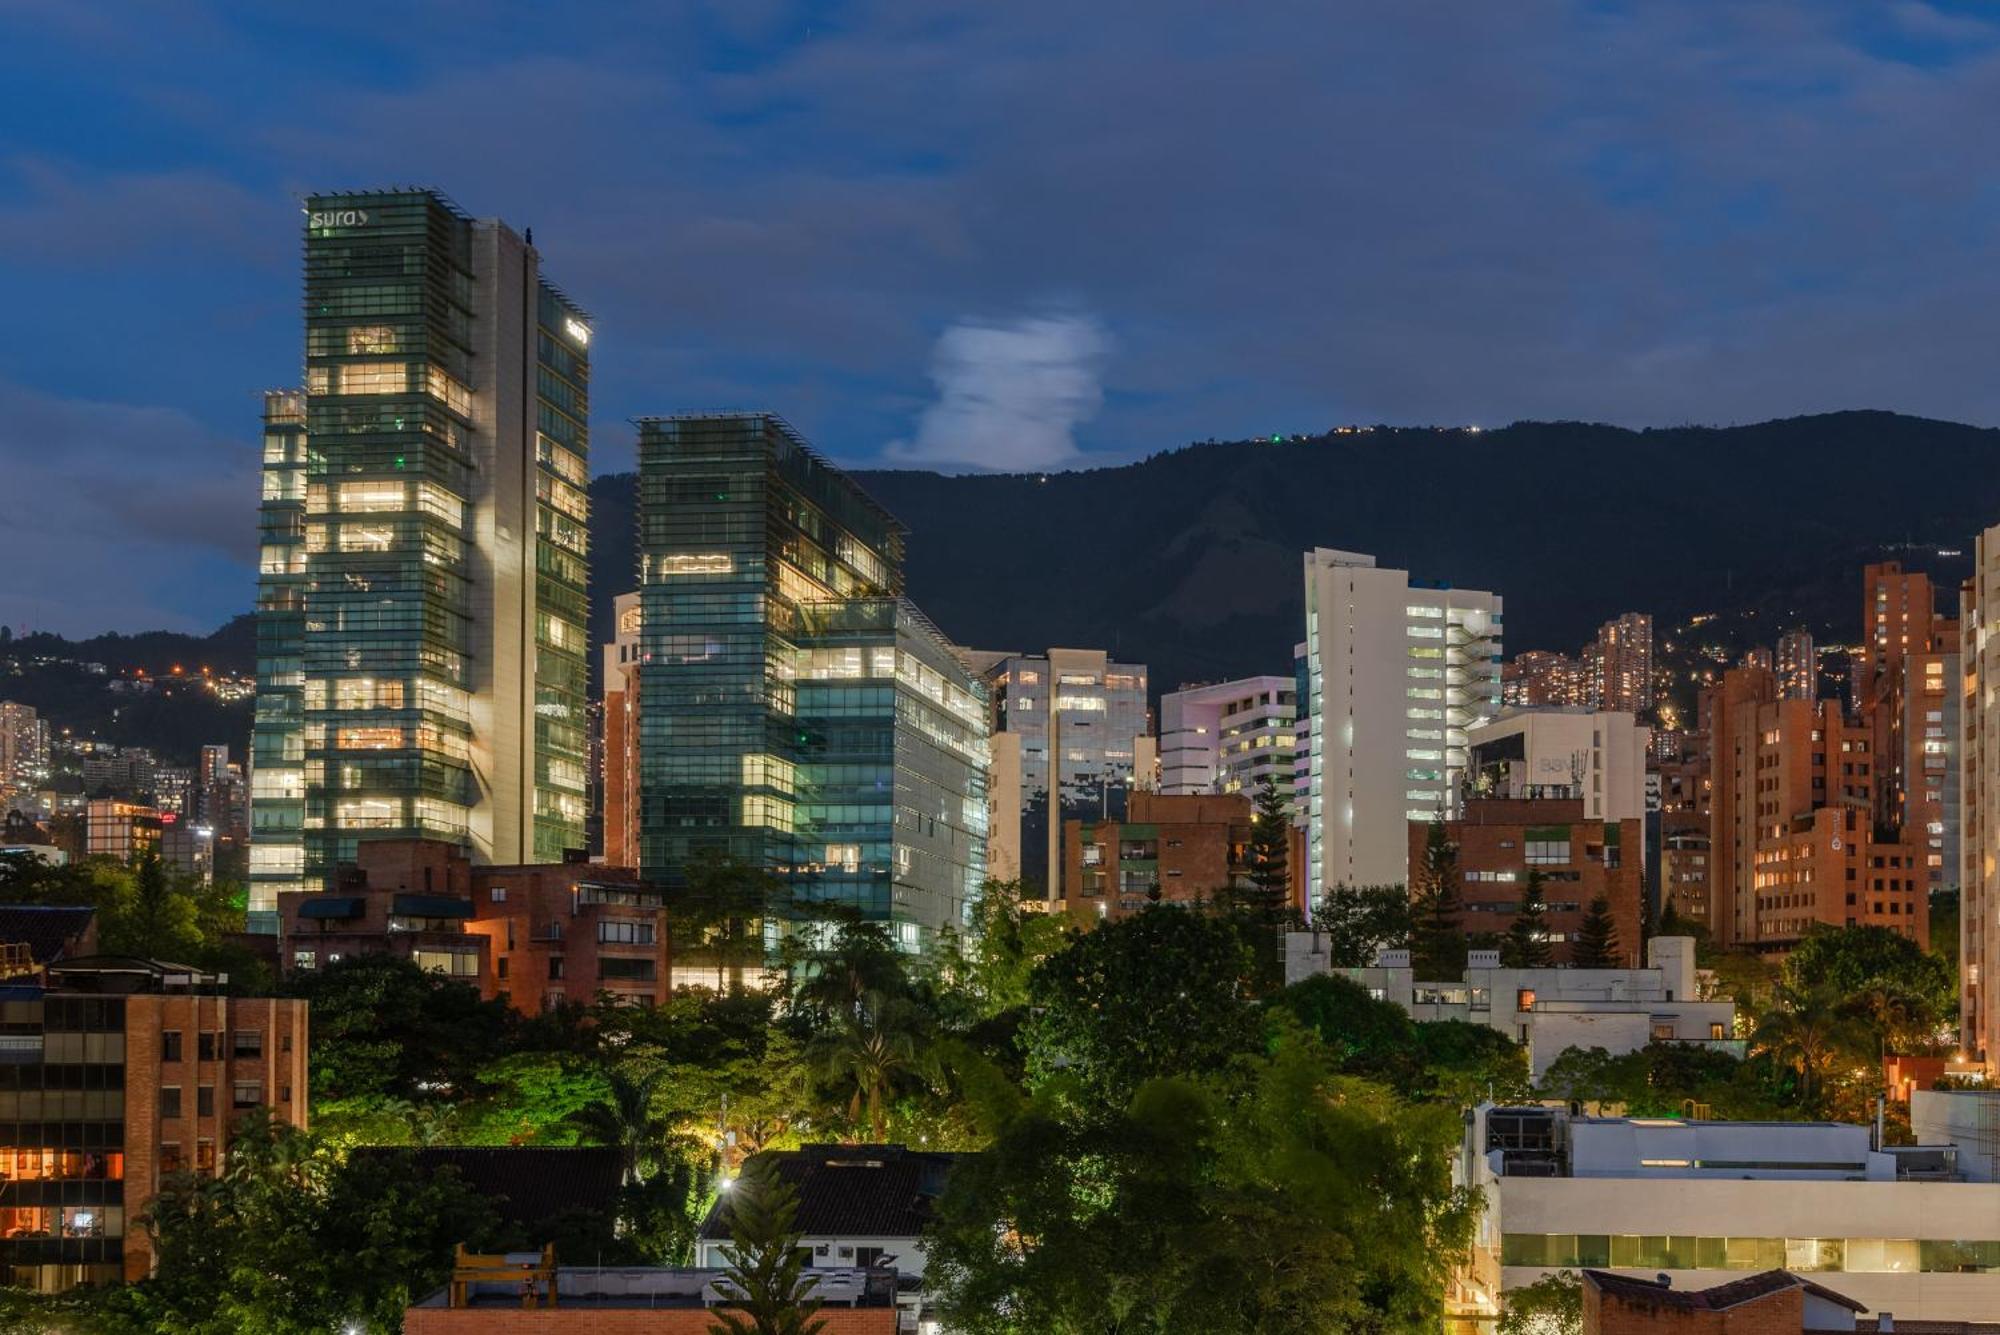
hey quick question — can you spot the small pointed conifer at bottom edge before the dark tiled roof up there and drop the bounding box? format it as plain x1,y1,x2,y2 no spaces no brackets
708,1159,826,1335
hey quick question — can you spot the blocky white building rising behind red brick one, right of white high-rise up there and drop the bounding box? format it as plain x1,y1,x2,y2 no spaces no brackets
1466,705,1652,821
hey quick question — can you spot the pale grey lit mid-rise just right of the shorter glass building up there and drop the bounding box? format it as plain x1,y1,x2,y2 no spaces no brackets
972,650,1158,899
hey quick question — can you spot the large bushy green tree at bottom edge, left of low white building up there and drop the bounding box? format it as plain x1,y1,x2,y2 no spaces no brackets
924,1027,1474,1335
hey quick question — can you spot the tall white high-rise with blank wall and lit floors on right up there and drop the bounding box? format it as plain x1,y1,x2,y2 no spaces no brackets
1300,548,1500,899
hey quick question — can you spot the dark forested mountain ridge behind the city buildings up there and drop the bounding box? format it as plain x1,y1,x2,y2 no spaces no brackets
592,410,2000,691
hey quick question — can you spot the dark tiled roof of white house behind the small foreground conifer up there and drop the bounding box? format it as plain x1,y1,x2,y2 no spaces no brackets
702,1145,960,1241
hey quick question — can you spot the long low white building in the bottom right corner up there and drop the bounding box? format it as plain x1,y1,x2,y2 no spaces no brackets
1462,1105,2000,1319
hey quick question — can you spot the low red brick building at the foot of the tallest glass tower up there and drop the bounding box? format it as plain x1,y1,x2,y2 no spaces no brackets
278,839,672,1015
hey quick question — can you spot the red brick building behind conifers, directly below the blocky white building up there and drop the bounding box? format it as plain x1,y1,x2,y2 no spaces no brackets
1410,797,1646,967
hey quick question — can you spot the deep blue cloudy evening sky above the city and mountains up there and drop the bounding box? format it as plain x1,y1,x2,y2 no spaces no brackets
0,0,2000,634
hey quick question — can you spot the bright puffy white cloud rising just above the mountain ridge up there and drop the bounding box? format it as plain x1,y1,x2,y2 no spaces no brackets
882,314,1110,472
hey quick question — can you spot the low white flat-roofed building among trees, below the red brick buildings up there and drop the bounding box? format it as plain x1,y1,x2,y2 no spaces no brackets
1284,931,1742,1079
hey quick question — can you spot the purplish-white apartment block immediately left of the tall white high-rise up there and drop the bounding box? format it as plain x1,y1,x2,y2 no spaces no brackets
1160,677,1298,799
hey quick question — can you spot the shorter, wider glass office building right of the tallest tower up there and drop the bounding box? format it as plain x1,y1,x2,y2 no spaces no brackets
640,414,988,949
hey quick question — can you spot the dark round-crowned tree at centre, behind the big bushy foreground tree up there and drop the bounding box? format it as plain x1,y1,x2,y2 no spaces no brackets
1022,903,1256,1109
